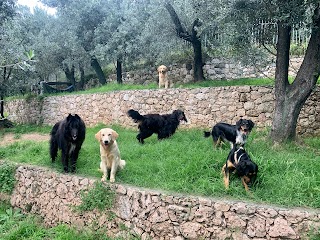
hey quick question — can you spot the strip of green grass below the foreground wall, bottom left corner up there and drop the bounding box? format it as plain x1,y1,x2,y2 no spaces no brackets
0,202,137,240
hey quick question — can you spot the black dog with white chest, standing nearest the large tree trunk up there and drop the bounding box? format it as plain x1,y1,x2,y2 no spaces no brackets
204,119,254,148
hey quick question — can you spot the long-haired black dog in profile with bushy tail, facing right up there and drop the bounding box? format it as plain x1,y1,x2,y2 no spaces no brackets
128,109,187,143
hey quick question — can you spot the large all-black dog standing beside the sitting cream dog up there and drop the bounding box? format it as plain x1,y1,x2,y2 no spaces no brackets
50,114,86,172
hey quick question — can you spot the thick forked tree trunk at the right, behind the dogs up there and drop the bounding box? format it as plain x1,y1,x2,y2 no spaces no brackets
271,5,320,142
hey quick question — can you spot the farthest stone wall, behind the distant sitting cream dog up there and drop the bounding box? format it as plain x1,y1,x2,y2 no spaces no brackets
105,58,303,86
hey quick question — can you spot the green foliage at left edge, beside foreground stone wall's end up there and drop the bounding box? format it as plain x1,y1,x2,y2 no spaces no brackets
0,162,16,194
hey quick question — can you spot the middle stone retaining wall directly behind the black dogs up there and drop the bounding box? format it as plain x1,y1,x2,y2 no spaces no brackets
5,86,320,135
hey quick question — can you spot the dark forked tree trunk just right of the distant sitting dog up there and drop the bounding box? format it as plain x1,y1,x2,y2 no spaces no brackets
165,2,204,82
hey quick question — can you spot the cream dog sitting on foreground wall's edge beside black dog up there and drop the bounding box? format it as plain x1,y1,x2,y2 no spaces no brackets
95,128,126,182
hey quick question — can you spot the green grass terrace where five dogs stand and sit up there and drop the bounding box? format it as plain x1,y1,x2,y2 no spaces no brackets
0,125,320,208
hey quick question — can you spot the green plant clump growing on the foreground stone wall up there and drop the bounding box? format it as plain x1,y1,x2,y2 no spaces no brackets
76,181,115,212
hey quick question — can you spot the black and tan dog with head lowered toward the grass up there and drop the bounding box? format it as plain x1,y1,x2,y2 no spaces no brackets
222,145,258,191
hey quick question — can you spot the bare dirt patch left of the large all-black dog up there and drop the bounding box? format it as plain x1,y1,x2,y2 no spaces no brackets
0,133,50,146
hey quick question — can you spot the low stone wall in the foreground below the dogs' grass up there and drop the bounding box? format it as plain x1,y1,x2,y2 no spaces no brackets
11,166,320,240
